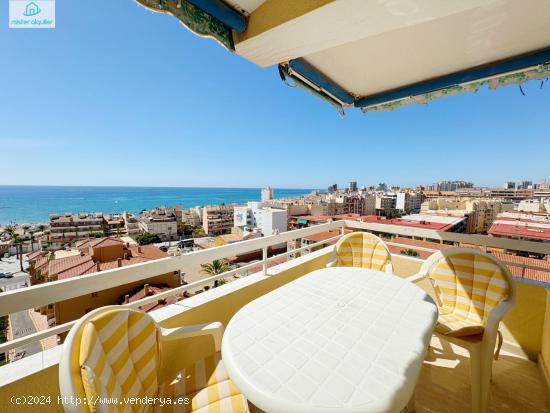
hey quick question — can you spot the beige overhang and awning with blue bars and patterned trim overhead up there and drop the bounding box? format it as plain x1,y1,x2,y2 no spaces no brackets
137,0,550,110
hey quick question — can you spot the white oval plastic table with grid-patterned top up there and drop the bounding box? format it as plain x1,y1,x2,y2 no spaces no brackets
222,267,437,413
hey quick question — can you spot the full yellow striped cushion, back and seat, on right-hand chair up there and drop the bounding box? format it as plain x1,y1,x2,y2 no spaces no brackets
429,253,509,337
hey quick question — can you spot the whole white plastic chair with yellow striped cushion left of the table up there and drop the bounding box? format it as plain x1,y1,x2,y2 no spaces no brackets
59,306,249,413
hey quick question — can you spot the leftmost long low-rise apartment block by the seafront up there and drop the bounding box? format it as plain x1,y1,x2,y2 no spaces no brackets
48,212,104,249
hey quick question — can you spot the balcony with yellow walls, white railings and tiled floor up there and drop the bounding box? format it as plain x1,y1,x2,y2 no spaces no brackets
0,221,550,413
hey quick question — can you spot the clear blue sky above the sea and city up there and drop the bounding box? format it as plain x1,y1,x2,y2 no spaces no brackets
0,0,550,188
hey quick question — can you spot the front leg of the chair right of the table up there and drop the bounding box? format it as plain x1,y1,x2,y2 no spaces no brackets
470,346,493,413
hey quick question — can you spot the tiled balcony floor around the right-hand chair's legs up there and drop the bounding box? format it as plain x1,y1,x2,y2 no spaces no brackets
416,337,550,413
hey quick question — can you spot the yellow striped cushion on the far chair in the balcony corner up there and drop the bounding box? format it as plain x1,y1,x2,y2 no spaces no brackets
336,232,391,271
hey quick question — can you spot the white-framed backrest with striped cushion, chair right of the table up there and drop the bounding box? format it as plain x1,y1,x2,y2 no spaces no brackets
420,248,515,326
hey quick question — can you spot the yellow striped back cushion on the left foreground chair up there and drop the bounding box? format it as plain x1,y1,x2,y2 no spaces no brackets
79,309,159,412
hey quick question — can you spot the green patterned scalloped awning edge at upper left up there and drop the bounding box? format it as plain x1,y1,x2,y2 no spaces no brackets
136,0,234,51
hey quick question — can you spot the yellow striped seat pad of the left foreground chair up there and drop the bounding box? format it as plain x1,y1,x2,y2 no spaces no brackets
155,352,248,413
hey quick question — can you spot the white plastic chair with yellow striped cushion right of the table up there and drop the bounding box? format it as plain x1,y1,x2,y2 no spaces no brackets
407,248,516,413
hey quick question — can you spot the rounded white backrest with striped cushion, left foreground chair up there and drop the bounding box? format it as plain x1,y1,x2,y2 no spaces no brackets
59,306,159,412
